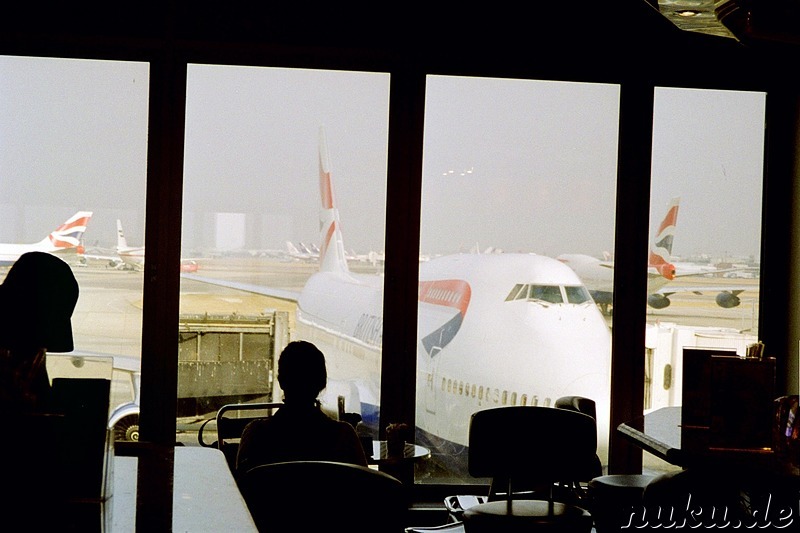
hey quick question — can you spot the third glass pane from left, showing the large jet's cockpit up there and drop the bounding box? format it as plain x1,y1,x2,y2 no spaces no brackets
416,76,619,482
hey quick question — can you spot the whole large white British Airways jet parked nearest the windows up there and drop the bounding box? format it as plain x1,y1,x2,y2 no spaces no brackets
183,131,611,474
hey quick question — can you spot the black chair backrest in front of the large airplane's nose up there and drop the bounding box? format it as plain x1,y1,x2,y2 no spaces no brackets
468,406,597,497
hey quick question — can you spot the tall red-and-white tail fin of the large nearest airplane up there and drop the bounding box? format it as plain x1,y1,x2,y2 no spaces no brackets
319,127,349,272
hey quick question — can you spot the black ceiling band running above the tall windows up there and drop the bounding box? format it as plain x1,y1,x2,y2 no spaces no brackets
0,0,798,85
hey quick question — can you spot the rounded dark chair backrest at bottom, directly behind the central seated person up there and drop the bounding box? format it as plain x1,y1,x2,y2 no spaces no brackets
239,461,408,533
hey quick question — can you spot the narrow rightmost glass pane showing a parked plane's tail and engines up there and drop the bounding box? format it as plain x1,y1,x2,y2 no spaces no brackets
644,87,766,474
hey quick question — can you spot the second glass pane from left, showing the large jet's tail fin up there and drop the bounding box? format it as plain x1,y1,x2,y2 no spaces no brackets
178,64,389,444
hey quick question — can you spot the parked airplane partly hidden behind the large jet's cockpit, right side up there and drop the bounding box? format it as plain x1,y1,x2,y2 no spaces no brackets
556,198,748,314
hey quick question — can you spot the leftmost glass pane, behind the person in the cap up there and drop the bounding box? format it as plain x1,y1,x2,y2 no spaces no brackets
0,56,149,440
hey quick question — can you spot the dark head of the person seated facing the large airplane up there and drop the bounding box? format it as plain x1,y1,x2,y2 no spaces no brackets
278,341,328,401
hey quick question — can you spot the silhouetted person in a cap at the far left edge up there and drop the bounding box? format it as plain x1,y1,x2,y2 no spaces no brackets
0,252,78,520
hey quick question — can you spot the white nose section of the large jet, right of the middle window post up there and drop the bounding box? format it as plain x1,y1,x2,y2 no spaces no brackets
417,254,611,462
